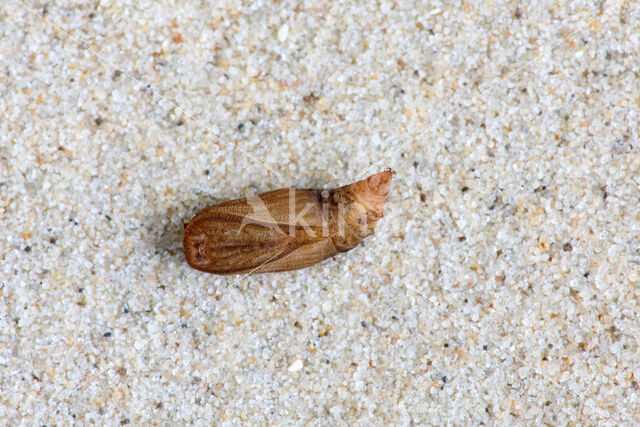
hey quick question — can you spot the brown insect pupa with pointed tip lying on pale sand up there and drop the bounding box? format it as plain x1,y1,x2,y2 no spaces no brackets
183,169,395,274
